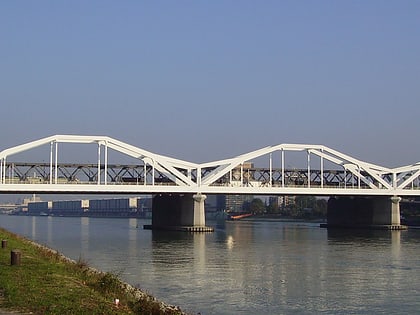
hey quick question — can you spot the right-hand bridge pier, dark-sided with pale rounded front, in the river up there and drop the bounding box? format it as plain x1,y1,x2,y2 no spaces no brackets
322,196,407,230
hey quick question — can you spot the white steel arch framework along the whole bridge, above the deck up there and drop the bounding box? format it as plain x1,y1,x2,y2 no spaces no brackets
0,135,420,193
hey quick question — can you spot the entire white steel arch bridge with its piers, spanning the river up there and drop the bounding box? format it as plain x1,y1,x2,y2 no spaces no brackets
0,135,420,232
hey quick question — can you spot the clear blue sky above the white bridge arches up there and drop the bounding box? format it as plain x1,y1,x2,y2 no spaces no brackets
0,0,420,167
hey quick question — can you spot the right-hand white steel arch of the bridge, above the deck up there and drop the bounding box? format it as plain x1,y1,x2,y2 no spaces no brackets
200,144,420,191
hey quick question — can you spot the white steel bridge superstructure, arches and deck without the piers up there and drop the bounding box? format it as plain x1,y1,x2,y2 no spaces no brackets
0,135,420,196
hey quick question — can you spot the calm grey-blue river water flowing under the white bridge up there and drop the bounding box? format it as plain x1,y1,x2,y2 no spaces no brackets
0,215,420,315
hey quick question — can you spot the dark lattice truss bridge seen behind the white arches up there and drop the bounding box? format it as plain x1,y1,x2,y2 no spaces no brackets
2,162,368,187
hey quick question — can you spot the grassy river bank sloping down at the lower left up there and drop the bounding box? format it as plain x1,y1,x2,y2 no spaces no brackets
0,229,187,315
